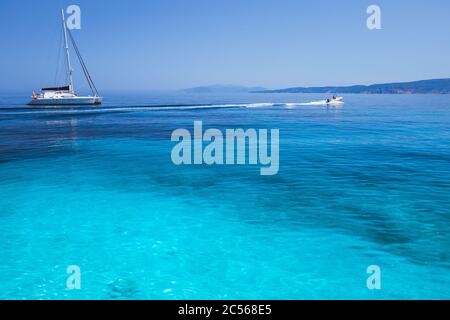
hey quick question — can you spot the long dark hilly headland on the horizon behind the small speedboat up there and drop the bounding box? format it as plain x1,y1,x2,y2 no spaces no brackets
252,79,450,94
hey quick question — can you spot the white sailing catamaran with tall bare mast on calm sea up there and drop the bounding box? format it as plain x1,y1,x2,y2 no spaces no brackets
28,10,102,105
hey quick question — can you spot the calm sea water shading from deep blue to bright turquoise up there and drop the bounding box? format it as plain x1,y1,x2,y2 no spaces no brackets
0,94,450,299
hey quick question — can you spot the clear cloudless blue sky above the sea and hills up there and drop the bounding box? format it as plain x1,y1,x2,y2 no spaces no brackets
0,0,450,91
